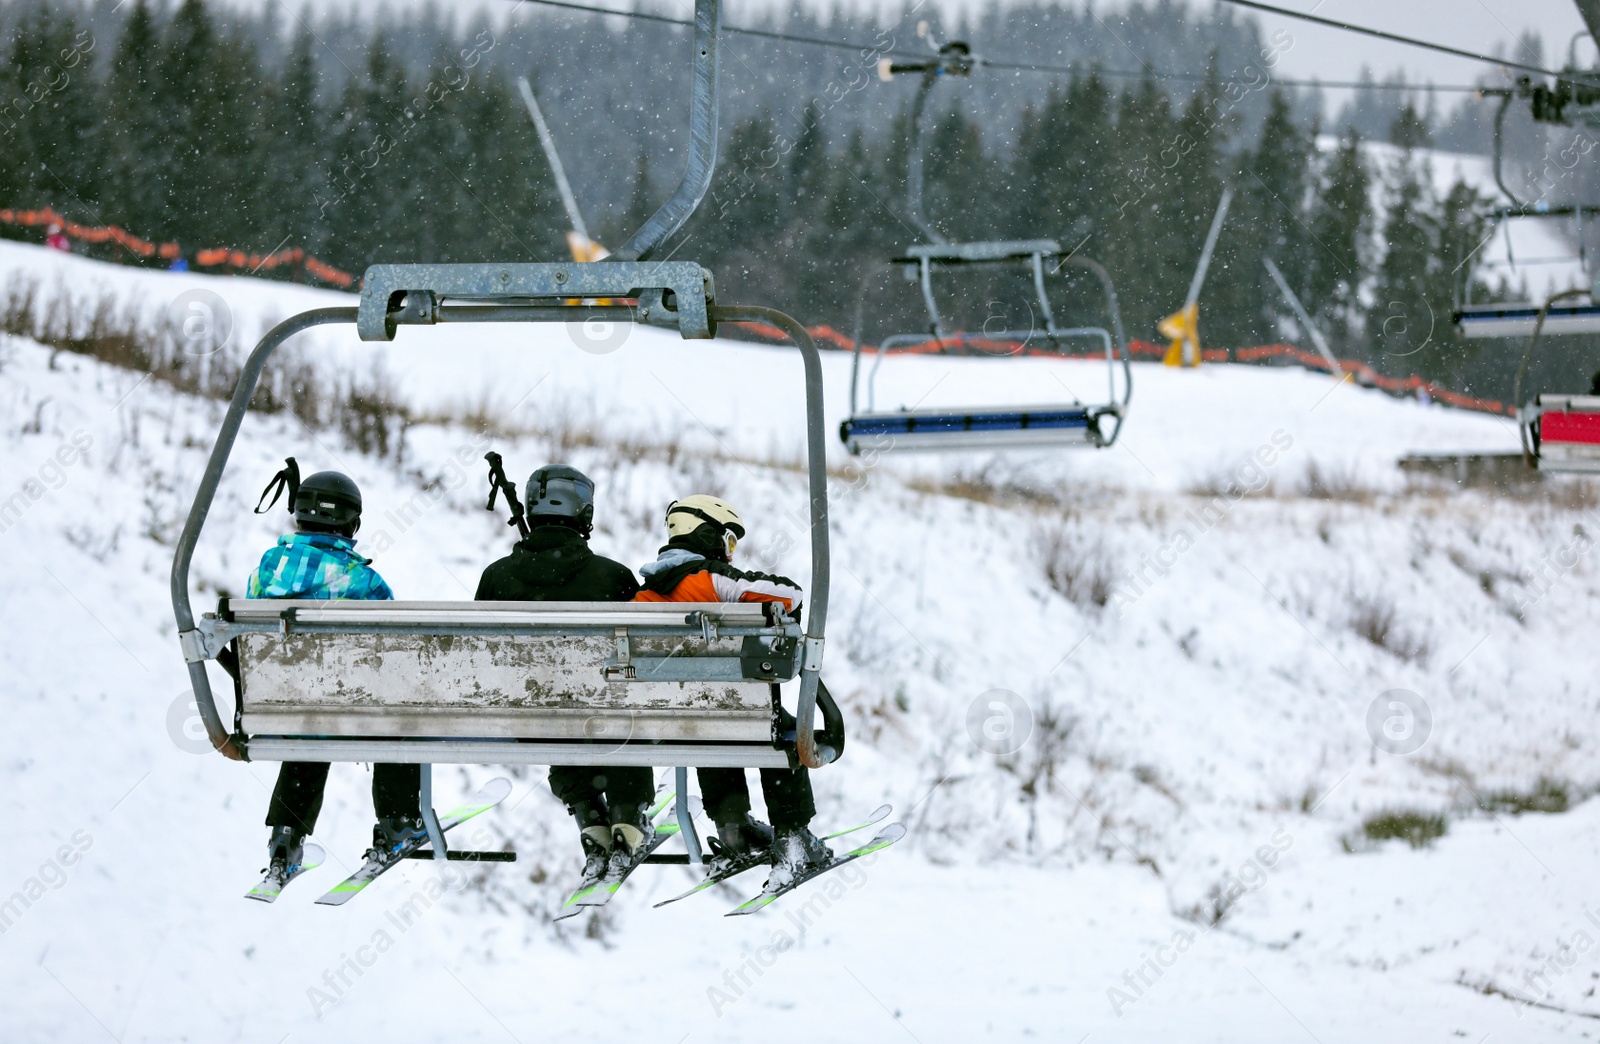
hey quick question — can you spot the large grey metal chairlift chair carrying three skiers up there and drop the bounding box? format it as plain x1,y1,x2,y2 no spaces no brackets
171,0,843,863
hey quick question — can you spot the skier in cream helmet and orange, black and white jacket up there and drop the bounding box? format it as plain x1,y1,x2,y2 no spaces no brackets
634,493,834,889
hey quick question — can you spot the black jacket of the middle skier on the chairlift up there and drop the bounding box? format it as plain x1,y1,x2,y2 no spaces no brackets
477,525,638,602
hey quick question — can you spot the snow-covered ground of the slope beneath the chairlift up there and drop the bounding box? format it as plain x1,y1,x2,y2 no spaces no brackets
0,245,1600,1044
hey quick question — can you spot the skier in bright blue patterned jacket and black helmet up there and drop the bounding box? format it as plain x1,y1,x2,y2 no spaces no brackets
248,456,426,882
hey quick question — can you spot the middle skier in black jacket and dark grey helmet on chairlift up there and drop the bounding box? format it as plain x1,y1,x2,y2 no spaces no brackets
477,456,654,887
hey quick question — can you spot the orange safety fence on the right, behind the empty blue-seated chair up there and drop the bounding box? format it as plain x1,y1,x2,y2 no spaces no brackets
728,322,1517,416
